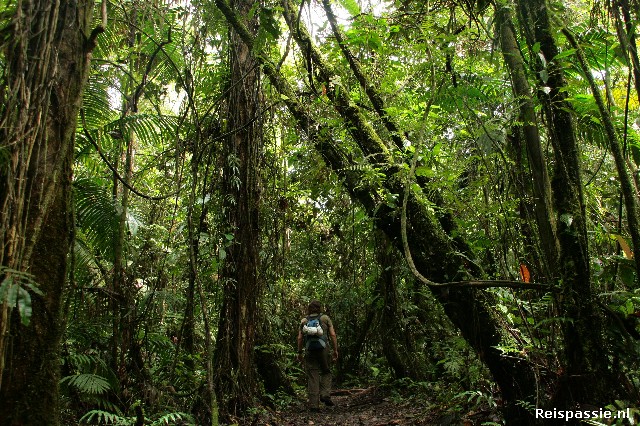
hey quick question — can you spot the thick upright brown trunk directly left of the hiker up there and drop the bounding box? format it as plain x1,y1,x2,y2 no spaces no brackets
214,0,262,415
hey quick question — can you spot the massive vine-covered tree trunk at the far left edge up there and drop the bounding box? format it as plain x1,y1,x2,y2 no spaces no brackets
0,0,99,425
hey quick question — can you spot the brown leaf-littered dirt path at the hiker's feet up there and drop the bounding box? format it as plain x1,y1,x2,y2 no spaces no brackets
251,388,499,426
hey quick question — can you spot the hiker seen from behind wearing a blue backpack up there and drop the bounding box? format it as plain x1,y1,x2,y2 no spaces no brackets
298,300,338,412
